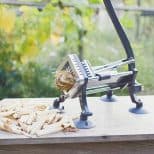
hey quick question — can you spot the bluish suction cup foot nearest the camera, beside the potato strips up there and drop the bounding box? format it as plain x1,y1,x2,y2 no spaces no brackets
74,119,95,129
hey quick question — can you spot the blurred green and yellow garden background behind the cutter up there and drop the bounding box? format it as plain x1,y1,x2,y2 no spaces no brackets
0,0,154,99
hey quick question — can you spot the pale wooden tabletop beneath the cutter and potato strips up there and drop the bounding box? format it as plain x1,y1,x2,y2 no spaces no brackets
0,96,154,145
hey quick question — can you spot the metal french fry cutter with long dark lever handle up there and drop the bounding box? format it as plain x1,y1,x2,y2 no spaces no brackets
54,0,143,129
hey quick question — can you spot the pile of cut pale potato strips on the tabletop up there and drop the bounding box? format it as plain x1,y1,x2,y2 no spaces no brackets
0,102,79,137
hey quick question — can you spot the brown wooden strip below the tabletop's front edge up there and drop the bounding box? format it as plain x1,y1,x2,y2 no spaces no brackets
0,141,154,154
